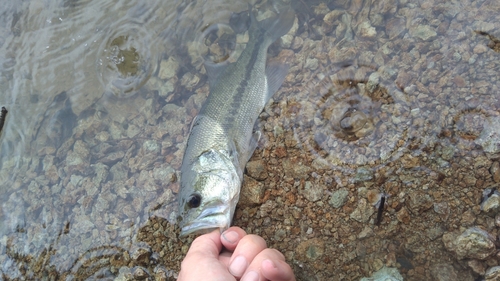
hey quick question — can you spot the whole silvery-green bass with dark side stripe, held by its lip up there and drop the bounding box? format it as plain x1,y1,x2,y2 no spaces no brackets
177,7,295,237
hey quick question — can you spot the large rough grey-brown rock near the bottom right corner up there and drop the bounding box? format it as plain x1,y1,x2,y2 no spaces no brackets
443,227,496,260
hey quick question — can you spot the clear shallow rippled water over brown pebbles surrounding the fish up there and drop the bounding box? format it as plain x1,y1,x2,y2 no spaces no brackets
0,0,500,280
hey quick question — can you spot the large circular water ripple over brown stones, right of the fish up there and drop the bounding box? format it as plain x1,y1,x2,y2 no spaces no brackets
289,62,412,170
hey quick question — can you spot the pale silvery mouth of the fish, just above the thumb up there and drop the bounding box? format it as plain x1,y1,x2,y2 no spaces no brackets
180,204,231,237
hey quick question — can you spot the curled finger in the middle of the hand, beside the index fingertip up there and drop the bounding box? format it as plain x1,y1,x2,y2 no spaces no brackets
228,234,267,278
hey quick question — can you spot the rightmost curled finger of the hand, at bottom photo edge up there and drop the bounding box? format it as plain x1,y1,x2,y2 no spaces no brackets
241,249,295,281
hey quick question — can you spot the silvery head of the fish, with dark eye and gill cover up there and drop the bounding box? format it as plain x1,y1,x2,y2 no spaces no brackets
178,150,241,236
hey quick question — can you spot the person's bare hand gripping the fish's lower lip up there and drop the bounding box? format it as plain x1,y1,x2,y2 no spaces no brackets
177,227,295,281
